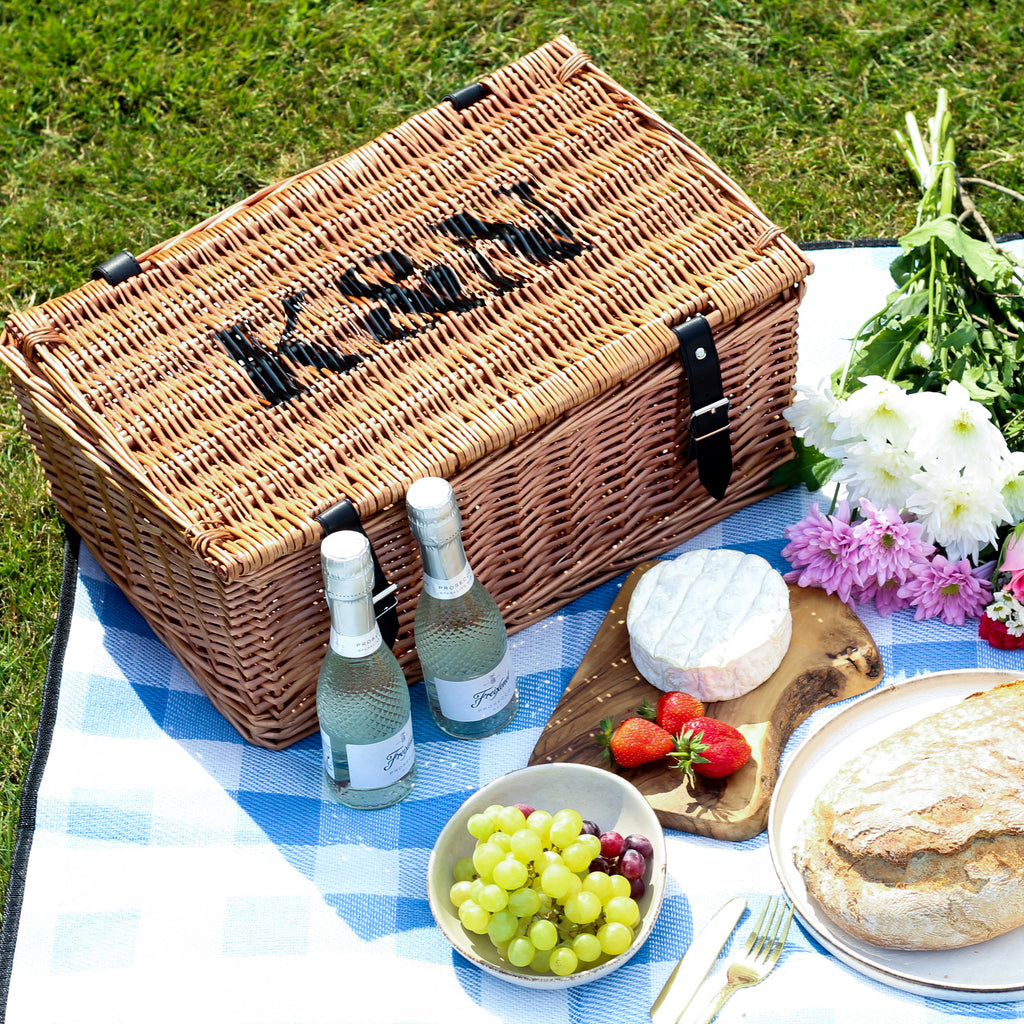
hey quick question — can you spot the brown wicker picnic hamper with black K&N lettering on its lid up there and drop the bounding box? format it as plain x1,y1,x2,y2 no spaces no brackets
0,38,811,748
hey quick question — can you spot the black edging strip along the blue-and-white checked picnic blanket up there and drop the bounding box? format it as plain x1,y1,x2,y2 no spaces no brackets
0,232,1024,1024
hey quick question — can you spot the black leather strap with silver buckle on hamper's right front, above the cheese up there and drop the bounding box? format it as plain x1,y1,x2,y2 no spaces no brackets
672,316,732,500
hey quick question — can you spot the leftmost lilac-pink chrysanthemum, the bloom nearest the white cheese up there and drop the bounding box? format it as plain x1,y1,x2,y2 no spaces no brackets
782,502,862,602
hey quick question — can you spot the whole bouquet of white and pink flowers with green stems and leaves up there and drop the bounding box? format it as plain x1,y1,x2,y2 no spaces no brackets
773,90,1024,647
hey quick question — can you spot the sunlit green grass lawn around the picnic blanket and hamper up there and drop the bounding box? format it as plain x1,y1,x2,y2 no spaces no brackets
0,0,1024,917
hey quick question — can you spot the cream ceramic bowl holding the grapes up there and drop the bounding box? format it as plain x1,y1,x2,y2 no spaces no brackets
427,763,666,989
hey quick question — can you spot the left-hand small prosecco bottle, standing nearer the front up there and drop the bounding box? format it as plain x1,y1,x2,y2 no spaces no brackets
316,530,416,810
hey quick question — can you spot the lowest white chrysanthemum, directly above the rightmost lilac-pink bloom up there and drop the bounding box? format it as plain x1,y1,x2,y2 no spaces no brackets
905,470,1010,563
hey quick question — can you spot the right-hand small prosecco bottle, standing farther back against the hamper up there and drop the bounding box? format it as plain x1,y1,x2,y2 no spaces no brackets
406,476,519,739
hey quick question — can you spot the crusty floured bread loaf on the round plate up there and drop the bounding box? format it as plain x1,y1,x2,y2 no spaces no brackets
794,680,1024,949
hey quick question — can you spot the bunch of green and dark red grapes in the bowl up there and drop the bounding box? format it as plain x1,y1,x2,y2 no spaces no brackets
450,804,653,976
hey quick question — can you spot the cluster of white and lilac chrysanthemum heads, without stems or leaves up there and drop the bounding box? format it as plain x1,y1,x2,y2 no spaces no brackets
782,377,1024,625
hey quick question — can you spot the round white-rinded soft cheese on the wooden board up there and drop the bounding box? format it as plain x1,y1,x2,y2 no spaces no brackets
626,549,793,701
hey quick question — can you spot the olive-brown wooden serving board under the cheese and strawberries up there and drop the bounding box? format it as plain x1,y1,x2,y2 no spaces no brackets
529,561,883,842
